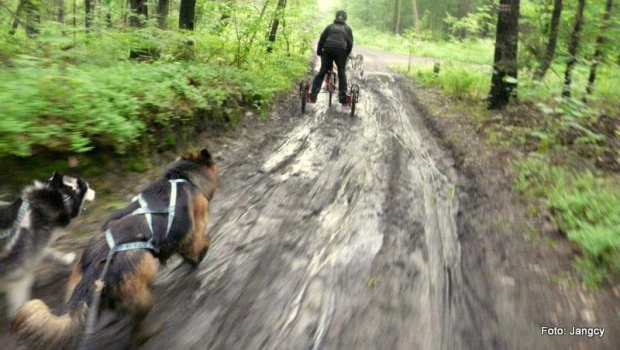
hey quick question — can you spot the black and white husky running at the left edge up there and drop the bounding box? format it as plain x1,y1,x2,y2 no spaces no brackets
0,173,95,317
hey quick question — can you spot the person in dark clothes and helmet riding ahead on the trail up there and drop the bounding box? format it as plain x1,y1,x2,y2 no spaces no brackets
310,10,353,104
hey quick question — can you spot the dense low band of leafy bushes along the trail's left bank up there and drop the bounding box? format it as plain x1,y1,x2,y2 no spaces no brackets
0,55,307,157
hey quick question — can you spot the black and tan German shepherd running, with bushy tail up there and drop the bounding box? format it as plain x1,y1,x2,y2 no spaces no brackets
12,149,218,349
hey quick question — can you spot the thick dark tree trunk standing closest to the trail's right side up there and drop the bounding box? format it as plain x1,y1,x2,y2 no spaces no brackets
488,0,520,109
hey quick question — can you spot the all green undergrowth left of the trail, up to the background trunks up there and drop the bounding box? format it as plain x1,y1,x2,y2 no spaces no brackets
0,0,315,157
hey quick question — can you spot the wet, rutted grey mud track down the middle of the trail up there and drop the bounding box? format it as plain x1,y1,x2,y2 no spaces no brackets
143,72,497,349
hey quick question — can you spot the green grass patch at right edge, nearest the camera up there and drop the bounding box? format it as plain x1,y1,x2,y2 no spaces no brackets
514,156,620,286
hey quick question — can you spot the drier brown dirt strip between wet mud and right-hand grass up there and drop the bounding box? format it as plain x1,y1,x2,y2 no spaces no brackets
397,78,620,349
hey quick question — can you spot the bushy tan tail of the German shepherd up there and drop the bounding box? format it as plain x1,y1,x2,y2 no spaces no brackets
12,299,88,349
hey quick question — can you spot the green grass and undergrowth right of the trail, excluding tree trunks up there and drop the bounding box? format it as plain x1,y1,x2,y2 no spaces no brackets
392,38,620,287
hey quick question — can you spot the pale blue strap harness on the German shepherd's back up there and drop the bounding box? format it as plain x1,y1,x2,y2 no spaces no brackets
105,179,187,254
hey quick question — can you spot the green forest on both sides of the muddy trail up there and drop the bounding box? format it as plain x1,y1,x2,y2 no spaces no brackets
0,0,620,286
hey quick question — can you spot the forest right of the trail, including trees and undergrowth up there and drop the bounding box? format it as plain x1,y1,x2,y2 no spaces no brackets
342,0,620,285
